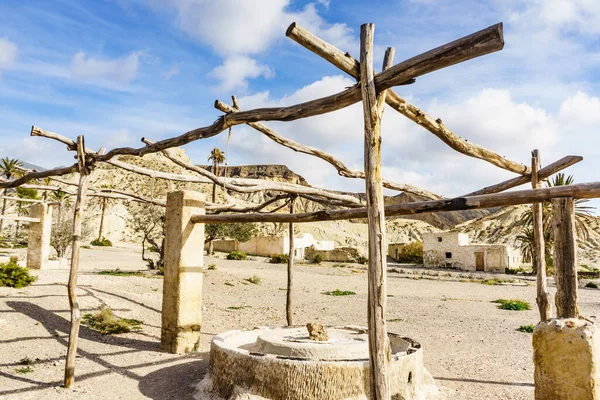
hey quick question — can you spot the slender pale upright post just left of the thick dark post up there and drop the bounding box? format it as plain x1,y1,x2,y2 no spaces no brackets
531,149,551,321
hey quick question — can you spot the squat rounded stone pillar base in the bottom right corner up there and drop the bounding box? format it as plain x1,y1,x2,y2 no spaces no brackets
533,318,600,400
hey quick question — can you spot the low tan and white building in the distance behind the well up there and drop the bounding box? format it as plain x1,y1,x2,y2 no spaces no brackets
213,233,335,259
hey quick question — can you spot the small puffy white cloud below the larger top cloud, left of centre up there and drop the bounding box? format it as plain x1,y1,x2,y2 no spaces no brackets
210,55,275,92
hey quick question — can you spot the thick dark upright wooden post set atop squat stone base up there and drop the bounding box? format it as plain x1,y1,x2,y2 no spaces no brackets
552,197,579,318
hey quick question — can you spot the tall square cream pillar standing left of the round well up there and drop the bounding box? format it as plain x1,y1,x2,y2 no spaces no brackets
160,190,204,353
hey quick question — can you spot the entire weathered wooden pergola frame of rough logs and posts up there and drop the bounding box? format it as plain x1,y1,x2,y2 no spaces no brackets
0,19,600,399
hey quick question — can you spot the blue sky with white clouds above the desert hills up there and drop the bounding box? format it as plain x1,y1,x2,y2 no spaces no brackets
0,0,600,206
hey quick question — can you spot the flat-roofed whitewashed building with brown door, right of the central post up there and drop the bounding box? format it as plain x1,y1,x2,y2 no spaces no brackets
423,232,522,272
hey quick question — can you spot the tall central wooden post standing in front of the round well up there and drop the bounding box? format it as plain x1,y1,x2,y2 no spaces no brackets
360,24,393,400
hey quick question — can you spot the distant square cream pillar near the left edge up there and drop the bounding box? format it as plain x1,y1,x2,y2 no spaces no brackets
27,203,52,269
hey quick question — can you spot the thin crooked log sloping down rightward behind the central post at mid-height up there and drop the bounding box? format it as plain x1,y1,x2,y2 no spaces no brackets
215,100,441,200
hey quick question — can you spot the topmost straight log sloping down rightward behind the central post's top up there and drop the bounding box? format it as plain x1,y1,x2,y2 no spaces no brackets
286,22,529,174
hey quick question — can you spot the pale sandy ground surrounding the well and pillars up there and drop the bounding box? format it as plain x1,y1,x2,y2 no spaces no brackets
0,248,600,400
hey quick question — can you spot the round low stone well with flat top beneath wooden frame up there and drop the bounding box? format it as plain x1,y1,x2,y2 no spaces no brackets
196,327,439,400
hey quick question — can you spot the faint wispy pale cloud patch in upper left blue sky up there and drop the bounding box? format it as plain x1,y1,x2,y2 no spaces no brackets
71,51,143,83
